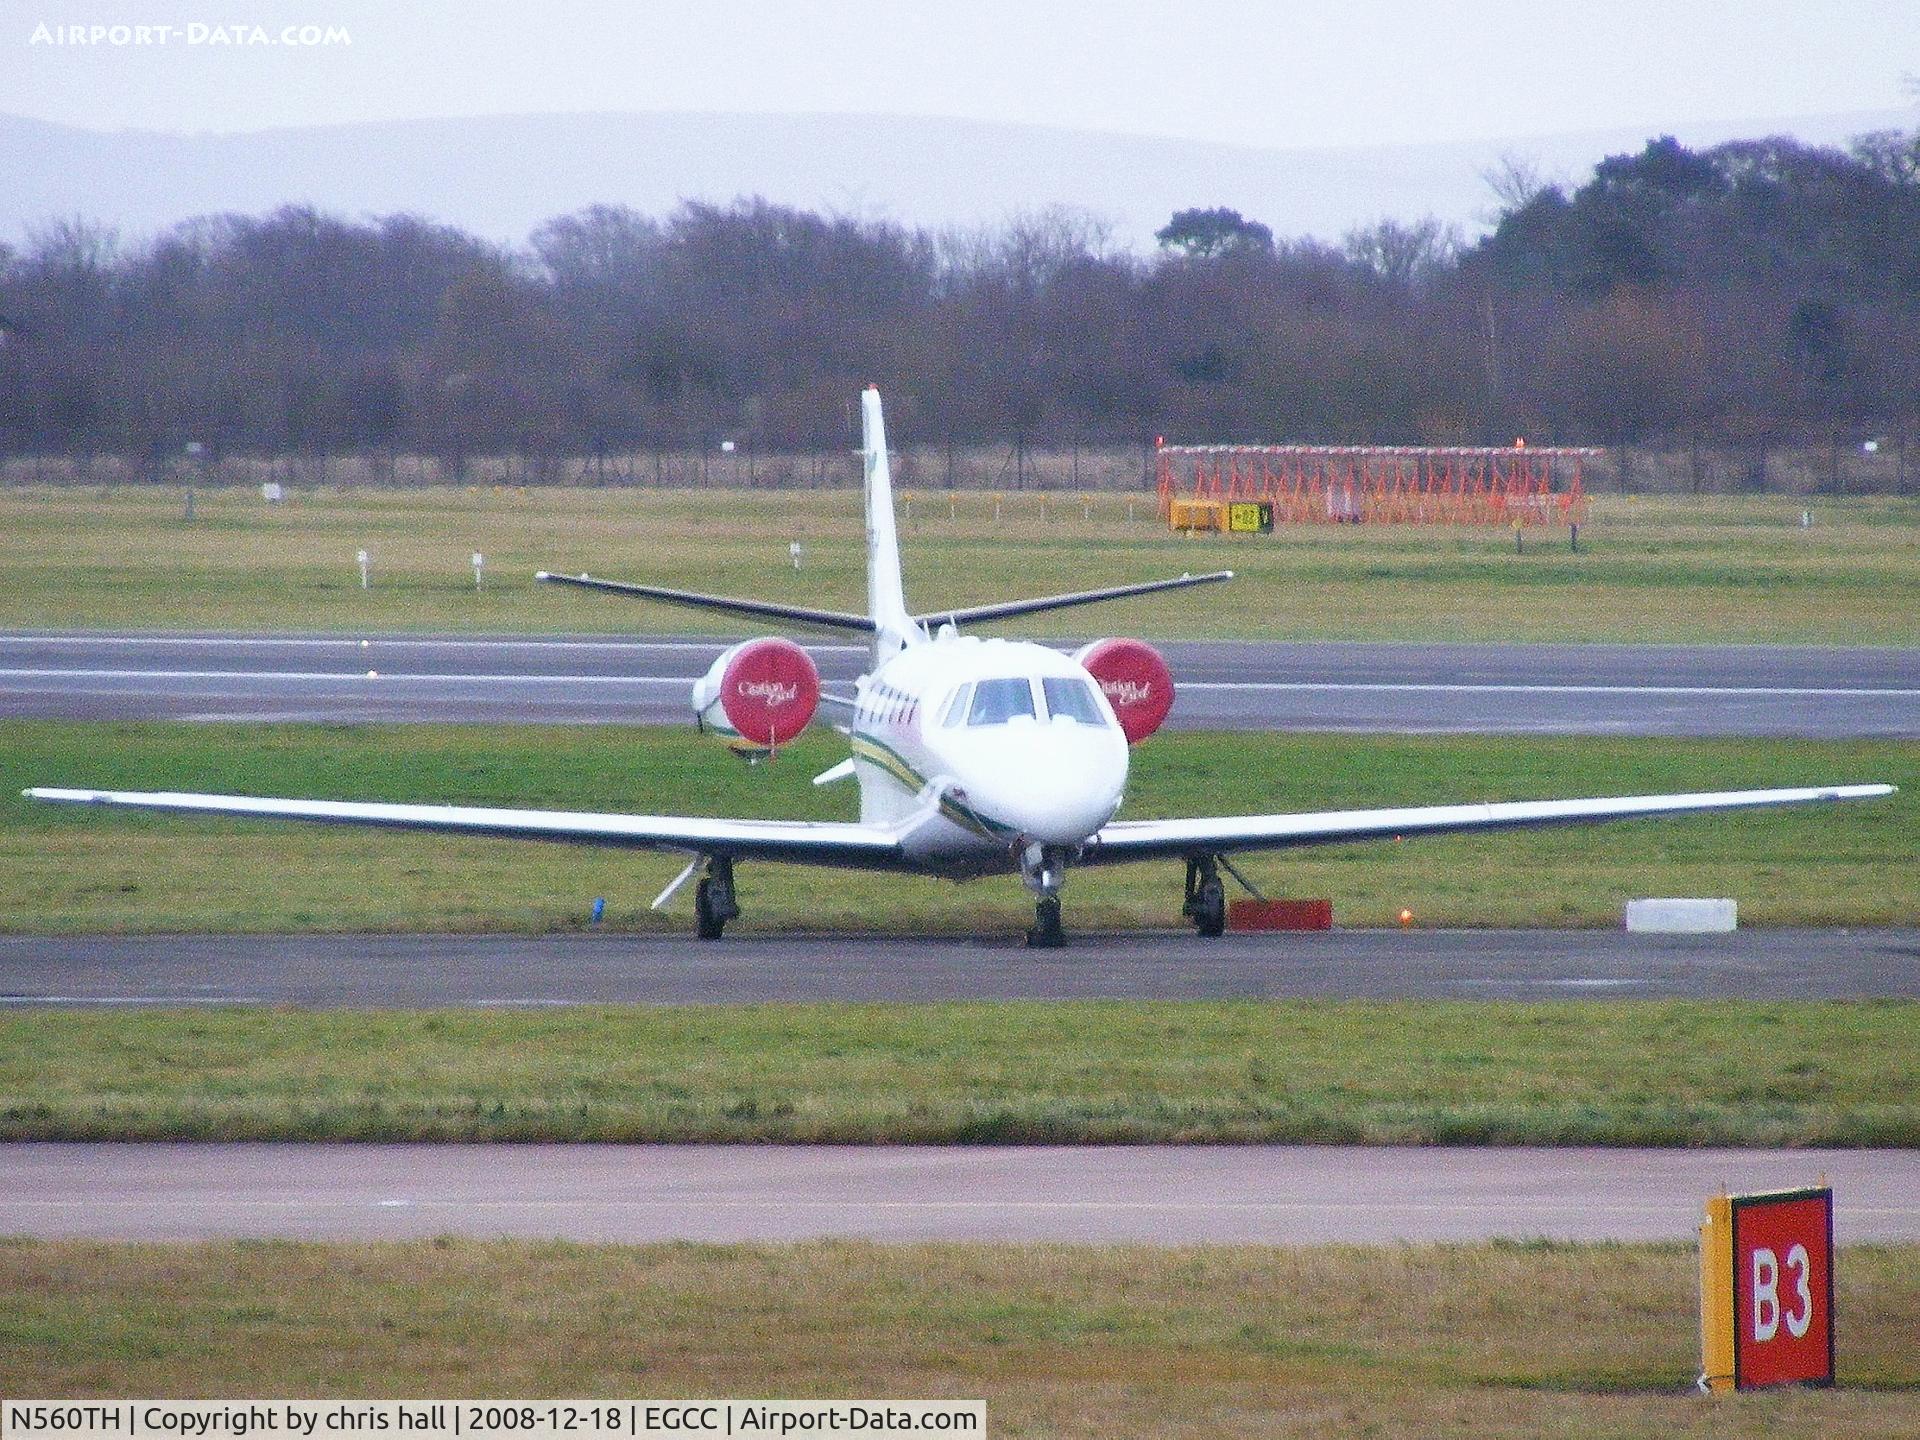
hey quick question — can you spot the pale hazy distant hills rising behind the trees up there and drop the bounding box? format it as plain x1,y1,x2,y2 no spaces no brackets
0,111,1914,250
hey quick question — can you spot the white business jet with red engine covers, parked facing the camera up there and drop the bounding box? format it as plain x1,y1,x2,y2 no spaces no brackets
25,388,1893,947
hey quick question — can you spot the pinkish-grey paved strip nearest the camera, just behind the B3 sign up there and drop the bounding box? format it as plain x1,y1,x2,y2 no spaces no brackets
0,1144,1920,1244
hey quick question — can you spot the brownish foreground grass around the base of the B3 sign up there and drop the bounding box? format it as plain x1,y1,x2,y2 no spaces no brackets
0,1240,1920,1440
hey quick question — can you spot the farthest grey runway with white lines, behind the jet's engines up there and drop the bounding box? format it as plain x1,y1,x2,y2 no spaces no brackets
0,634,1920,739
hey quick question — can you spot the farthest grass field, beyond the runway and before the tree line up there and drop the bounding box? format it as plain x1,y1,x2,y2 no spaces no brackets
0,488,1920,645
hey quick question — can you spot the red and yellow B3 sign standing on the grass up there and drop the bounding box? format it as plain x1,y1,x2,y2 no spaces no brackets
1699,1187,1834,1390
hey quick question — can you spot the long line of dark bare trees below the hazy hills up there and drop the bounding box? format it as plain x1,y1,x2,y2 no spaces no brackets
0,131,1920,468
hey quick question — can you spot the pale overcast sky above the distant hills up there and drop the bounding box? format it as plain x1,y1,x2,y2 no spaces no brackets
11,0,1920,148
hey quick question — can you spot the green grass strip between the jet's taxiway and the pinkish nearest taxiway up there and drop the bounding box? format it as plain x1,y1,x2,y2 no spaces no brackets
0,1000,1920,1146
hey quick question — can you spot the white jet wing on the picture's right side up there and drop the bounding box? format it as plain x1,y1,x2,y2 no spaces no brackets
1079,785,1895,864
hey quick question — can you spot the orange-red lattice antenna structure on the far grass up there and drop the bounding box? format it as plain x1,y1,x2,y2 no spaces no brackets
1158,445,1599,524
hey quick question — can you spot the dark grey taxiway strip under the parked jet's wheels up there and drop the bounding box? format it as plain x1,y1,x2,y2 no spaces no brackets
0,929,1920,1008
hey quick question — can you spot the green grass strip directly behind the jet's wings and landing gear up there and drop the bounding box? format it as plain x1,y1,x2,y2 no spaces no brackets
0,722,1920,933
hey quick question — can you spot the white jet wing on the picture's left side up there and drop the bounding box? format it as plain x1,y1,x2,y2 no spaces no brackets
23,789,902,870
